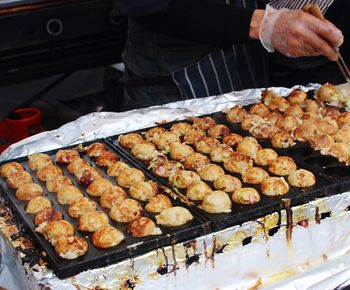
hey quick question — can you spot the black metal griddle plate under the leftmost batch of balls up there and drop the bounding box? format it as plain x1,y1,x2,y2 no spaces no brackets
0,140,210,278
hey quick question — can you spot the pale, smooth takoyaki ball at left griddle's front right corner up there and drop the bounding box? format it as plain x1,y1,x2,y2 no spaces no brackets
156,206,193,227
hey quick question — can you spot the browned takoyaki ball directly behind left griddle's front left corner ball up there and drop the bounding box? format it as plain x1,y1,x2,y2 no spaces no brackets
43,220,74,246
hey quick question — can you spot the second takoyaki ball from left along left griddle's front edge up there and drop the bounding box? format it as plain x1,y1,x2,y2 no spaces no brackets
91,226,125,249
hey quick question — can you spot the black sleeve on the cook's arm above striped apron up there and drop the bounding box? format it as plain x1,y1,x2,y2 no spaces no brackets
133,0,254,46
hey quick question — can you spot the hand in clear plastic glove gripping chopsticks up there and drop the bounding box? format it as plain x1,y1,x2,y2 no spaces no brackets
259,5,344,60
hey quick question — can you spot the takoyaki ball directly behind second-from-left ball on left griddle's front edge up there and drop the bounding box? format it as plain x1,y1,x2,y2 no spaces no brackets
78,210,109,232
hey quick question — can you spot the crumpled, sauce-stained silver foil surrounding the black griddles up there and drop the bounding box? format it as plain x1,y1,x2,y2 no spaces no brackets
0,84,350,290
